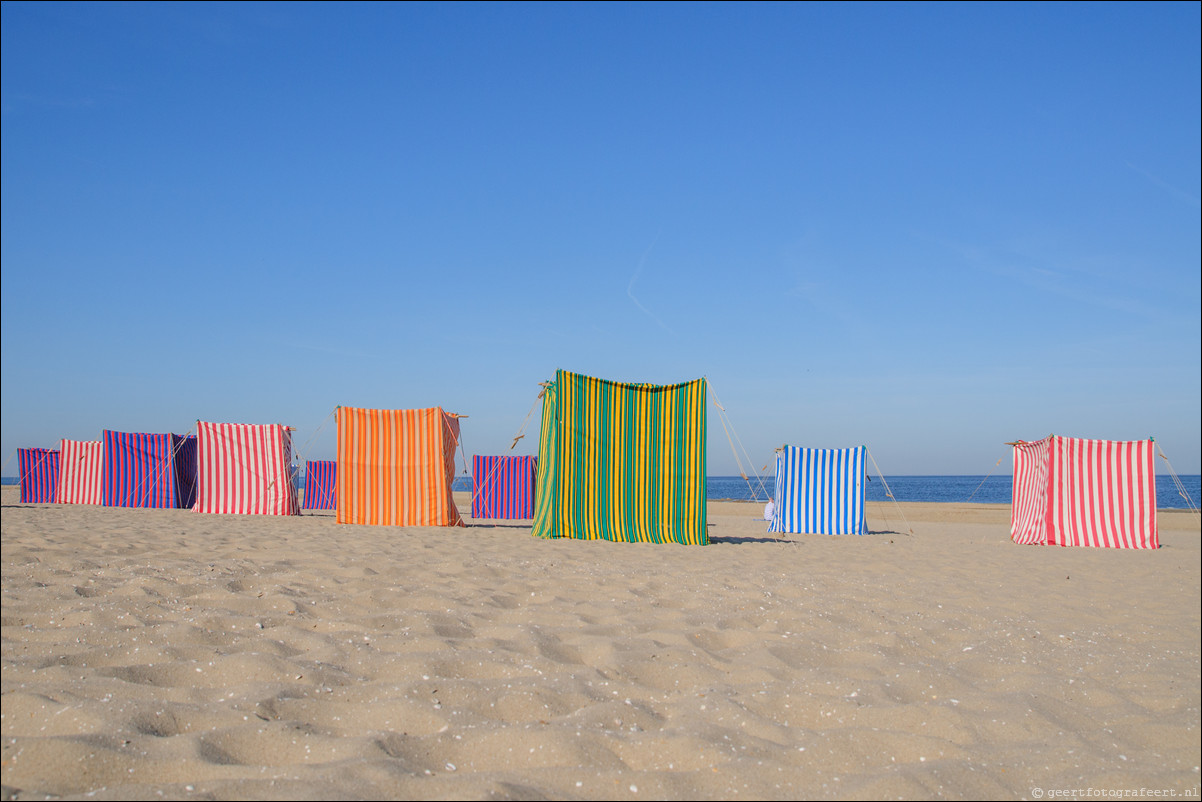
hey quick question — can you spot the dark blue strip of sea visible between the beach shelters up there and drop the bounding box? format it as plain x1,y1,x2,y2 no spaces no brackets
0,474,1202,510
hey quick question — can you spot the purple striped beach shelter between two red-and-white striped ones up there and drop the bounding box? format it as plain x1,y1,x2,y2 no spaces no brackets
101,430,187,507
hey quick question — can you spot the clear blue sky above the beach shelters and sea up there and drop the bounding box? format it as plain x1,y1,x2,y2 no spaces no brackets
0,2,1202,475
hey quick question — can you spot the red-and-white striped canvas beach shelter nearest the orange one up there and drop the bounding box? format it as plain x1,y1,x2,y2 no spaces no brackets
194,421,298,515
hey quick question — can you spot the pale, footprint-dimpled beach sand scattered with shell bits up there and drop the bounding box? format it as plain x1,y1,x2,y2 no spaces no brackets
0,487,1202,800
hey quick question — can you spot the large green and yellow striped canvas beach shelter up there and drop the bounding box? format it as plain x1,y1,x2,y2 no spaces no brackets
531,370,709,545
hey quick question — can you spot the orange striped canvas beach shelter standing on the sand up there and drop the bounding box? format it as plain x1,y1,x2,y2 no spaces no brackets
337,406,464,527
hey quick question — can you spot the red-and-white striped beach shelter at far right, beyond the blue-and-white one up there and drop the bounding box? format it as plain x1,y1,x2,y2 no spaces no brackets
1011,435,1160,548
